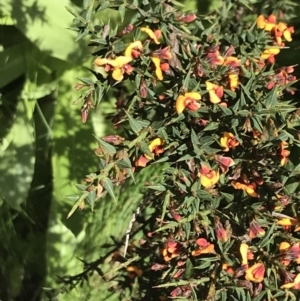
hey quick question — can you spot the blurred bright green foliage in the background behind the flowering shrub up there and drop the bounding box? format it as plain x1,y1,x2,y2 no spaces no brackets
0,0,300,301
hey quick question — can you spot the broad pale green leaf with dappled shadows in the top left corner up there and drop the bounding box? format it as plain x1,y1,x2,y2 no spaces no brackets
1,0,85,63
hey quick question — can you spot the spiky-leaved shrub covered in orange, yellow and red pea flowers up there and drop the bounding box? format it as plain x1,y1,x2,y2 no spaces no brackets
70,0,300,301
